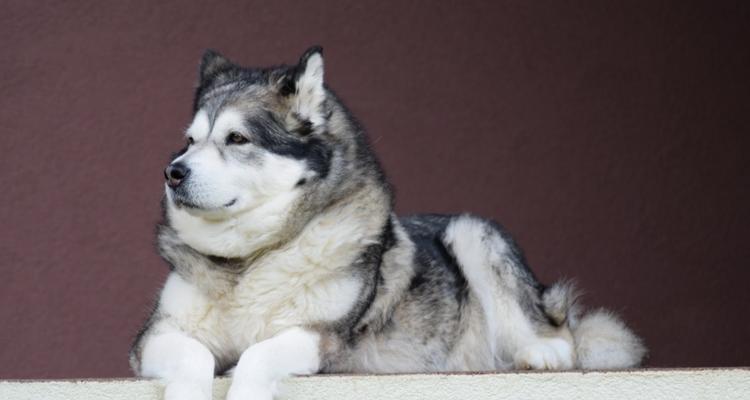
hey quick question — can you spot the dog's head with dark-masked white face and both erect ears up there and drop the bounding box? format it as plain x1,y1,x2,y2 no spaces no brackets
164,47,378,257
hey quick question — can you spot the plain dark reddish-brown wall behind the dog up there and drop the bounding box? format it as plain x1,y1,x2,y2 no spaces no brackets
0,0,750,378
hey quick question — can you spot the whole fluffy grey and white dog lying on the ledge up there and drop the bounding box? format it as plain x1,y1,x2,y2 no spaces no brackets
130,47,645,400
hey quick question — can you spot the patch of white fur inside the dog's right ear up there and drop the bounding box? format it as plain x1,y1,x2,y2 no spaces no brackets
293,53,326,127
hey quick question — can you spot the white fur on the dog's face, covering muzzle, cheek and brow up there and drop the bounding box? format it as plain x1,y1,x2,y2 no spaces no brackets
172,109,306,257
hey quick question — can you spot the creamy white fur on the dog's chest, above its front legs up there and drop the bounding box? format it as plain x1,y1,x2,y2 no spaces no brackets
160,191,388,358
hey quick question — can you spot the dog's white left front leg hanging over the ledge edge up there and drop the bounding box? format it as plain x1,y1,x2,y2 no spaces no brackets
138,332,215,400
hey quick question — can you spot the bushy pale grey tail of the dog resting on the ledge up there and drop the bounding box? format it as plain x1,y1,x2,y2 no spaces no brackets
542,282,646,369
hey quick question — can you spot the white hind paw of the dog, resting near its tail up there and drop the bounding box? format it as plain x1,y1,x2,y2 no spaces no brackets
513,338,574,370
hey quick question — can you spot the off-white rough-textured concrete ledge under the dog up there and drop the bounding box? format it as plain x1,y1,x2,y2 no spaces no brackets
0,368,750,400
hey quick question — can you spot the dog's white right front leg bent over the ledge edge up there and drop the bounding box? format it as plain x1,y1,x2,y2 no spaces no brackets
227,328,320,400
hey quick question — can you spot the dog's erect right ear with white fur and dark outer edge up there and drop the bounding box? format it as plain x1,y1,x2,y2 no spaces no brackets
291,46,326,127
